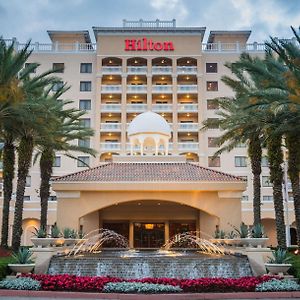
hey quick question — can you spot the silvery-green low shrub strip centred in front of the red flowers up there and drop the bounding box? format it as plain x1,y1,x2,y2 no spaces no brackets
103,281,182,294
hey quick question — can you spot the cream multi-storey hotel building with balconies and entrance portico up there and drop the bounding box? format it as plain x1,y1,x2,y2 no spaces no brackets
1,20,295,247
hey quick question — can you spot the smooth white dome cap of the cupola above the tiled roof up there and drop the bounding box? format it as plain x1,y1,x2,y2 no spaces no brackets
127,111,171,137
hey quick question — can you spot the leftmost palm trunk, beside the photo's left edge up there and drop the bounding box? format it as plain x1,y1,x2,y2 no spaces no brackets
1,137,15,247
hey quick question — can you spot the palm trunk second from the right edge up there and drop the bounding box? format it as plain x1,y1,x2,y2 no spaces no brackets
267,132,286,249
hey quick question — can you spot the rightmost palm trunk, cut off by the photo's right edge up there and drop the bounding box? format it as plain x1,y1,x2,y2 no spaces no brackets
286,134,300,248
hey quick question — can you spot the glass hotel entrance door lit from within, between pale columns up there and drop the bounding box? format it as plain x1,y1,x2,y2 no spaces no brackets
133,223,165,248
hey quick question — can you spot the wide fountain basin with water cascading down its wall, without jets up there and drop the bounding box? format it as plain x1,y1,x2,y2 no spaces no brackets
48,250,252,279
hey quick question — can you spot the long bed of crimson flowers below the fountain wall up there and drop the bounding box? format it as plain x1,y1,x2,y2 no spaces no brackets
23,274,274,293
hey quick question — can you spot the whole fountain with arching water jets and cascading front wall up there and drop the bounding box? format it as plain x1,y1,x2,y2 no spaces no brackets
48,229,252,279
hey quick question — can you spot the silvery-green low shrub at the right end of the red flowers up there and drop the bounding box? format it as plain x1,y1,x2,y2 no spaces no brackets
255,279,300,292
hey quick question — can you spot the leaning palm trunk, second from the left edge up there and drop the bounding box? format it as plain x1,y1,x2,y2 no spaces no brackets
12,137,33,251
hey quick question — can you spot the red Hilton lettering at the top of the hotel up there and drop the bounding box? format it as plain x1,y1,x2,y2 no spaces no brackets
125,38,174,51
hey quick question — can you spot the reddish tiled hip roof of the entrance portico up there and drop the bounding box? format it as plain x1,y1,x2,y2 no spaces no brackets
53,162,244,182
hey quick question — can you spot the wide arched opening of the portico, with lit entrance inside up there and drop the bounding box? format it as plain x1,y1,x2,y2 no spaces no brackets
80,200,219,248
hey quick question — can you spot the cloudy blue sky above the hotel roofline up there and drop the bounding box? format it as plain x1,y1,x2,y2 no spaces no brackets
0,0,300,43
